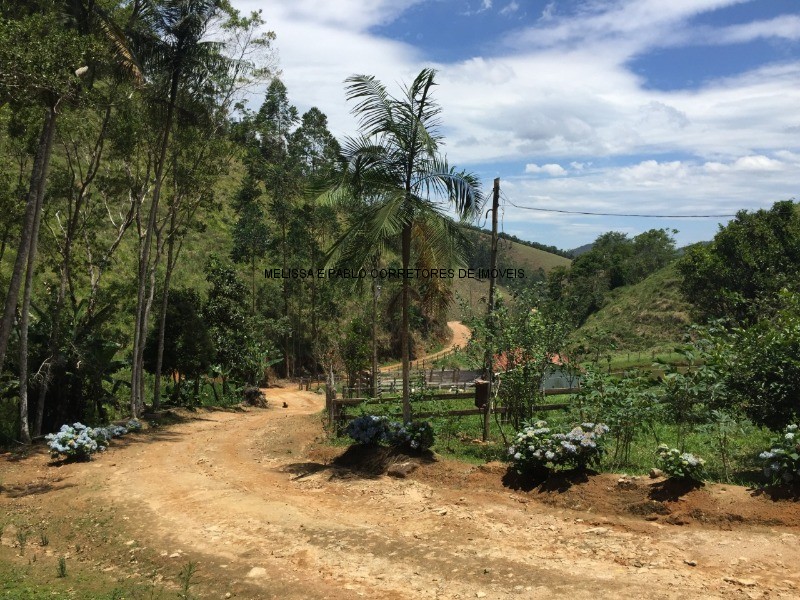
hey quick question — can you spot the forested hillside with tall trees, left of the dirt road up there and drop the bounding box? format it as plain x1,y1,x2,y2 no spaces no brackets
0,0,490,441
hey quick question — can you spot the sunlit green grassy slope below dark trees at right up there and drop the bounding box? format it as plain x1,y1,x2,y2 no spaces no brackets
571,263,690,351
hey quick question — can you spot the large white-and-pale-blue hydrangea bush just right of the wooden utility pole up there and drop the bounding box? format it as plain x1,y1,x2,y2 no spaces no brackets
508,421,608,474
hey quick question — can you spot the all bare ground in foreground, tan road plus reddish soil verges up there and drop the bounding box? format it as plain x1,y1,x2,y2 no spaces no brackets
0,385,800,600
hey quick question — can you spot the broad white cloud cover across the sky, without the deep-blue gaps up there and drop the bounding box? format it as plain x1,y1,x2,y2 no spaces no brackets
227,0,800,247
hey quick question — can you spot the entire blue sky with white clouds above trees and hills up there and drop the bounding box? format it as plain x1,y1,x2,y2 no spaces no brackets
233,0,800,249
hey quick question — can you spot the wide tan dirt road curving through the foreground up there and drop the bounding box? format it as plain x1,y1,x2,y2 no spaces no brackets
87,388,800,600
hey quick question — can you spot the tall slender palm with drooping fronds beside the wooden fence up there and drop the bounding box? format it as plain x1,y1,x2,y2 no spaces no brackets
330,69,483,421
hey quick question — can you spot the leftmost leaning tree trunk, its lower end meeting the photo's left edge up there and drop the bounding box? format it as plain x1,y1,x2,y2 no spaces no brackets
0,106,56,371
